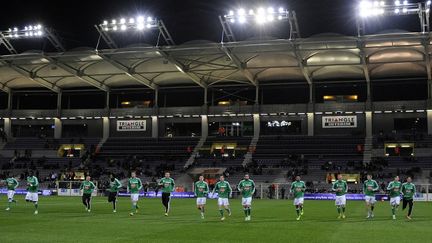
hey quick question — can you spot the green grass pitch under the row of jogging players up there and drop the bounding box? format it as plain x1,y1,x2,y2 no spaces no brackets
0,195,432,243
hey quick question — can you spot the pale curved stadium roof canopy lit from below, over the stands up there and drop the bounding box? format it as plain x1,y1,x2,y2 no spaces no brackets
0,33,432,92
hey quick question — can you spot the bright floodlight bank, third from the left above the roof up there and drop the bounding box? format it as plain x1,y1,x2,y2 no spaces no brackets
224,6,289,25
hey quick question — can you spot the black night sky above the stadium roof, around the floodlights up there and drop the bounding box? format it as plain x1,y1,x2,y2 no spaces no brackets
0,0,426,54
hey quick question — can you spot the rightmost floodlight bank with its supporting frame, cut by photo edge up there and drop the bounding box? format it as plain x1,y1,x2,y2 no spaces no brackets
357,0,431,36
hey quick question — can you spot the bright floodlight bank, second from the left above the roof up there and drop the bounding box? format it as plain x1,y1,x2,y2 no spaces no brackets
99,16,158,32
